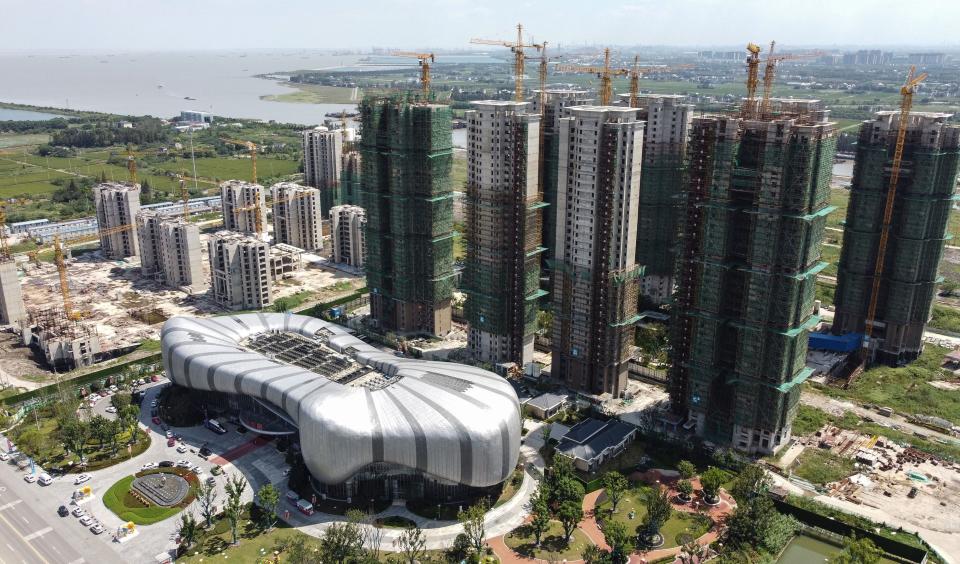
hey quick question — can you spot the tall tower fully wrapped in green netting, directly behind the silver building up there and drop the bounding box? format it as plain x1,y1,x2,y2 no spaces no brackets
358,97,454,335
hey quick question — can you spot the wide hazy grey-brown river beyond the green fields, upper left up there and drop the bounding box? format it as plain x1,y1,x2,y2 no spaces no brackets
0,49,360,125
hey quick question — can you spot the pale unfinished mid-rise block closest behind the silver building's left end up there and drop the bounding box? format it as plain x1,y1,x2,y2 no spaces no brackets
207,231,273,309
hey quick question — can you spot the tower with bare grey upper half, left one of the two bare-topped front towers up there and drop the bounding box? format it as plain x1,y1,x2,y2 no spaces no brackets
463,100,546,366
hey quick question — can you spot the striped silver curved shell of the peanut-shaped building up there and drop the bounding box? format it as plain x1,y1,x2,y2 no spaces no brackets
161,313,520,487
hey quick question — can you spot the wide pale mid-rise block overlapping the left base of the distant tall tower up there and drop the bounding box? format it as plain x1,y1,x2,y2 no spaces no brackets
270,182,323,251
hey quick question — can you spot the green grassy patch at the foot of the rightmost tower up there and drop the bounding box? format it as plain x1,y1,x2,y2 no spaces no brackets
815,344,960,425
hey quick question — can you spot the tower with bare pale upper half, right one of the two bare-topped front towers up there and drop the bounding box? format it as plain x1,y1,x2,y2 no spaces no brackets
551,106,644,397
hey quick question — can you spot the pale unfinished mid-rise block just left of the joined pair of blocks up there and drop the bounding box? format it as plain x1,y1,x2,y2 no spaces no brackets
93,182,140,259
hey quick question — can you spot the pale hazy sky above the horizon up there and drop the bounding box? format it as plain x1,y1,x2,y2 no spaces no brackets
0,0,960,51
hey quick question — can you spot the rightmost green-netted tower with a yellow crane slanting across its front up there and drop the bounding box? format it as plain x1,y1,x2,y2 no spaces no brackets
833,111,960,365
